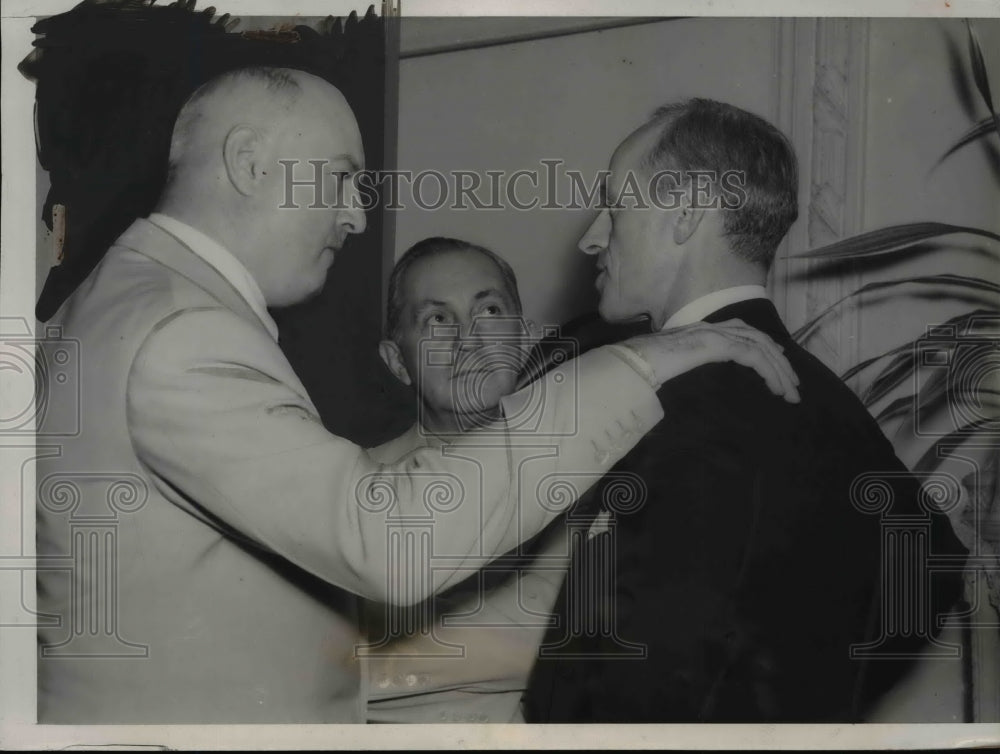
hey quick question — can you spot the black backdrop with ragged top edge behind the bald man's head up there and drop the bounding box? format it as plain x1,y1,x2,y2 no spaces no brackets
20,0,414,445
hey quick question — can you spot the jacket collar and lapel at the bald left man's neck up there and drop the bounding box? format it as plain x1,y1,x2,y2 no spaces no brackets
115,219,263,334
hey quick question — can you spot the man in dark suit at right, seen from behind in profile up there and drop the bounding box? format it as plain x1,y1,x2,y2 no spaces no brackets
524,100,966,722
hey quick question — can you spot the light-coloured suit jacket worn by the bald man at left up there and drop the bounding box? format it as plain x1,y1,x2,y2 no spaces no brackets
37,220,662,723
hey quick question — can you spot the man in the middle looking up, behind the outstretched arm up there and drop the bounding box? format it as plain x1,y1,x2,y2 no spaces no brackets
363,238,568,723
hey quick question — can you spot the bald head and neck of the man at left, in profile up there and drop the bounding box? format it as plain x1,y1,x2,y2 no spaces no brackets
157,68,365,306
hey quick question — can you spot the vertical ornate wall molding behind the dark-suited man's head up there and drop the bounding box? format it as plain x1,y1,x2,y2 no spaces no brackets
775,18,868,372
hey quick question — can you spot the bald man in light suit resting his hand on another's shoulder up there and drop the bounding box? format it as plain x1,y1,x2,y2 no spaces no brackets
37,68,794,723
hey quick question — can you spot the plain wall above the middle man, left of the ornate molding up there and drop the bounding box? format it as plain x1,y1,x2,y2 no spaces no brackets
395,19,792,323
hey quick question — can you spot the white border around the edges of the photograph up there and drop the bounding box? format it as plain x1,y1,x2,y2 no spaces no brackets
0,0,1000,750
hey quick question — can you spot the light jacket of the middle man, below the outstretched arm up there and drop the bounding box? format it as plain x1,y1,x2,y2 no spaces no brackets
362,424,570,723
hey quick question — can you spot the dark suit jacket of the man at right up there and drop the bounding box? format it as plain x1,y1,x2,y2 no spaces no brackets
525,299,965,722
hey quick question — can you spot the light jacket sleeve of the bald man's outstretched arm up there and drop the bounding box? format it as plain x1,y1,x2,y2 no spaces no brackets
126,302,663,604
